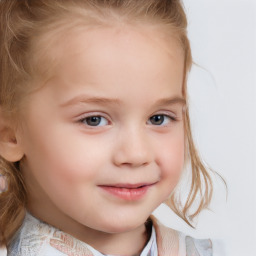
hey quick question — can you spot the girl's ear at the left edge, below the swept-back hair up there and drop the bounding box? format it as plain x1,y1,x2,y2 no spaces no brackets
0,108,24,162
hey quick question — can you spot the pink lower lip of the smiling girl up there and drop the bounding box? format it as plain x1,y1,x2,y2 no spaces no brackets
100,185,152,201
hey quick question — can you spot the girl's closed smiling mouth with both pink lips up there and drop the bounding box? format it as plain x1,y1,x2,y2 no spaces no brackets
99,183,156,201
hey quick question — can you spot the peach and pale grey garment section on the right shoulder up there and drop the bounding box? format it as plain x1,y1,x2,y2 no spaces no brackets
152,217,213,256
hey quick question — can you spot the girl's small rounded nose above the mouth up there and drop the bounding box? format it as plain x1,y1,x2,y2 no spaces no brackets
113,126,153,168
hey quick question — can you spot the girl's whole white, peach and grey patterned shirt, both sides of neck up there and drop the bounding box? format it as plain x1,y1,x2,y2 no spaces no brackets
7,213,212,256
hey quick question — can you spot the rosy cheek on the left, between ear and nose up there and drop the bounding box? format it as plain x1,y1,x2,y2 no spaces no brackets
23,125,114,189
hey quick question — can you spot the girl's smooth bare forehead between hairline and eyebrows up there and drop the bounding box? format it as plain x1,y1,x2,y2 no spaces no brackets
30,25,184,105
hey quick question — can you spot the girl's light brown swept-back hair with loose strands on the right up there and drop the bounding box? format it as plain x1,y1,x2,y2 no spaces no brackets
0,0,212,245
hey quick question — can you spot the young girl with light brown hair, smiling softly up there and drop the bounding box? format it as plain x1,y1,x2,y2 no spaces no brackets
0,0,212,256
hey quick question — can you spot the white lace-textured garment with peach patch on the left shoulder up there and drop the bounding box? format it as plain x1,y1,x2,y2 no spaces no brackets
7,214,92,256
